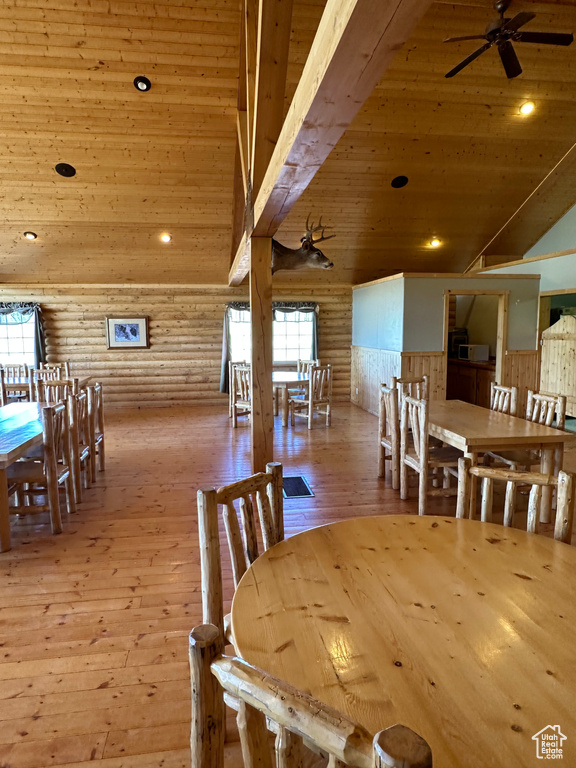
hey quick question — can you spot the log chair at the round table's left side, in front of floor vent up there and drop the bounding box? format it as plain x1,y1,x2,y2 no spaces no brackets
197,462,284,642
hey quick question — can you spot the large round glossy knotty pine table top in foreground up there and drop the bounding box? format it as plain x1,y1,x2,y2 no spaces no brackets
232,515,576,768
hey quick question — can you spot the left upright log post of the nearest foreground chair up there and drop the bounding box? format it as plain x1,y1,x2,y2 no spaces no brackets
189,624,225,768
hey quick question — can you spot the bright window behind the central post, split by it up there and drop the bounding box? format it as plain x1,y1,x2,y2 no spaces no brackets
229,308,315,364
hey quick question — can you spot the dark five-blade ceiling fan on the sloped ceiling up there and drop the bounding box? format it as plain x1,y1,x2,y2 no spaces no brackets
444,0,574,78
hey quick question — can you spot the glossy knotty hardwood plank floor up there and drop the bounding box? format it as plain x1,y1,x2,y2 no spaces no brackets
0,404,572,768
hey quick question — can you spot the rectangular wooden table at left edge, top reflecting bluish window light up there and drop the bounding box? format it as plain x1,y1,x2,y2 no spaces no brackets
0,403,42,552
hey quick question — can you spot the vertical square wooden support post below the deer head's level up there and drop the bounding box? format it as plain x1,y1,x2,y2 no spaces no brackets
250,237,274,472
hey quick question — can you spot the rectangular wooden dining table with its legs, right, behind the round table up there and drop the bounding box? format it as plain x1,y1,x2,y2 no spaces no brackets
428,400,576,523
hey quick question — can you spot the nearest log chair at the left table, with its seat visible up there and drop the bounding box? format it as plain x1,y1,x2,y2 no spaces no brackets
7,403,76,533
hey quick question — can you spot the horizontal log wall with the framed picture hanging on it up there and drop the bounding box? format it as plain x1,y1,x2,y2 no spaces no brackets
0,285,352,407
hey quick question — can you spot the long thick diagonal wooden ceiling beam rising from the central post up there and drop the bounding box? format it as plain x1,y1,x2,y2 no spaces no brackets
229,0,432,285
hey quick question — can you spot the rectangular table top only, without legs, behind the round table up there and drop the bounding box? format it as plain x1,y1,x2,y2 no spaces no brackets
429,400,576,453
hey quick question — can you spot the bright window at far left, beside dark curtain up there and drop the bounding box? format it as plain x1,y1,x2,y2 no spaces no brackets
0,302,45,367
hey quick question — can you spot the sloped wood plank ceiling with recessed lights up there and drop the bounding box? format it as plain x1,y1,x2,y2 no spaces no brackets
0,0,576,283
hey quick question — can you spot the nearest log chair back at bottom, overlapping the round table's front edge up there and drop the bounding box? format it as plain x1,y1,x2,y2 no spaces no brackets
189,624,432,768
